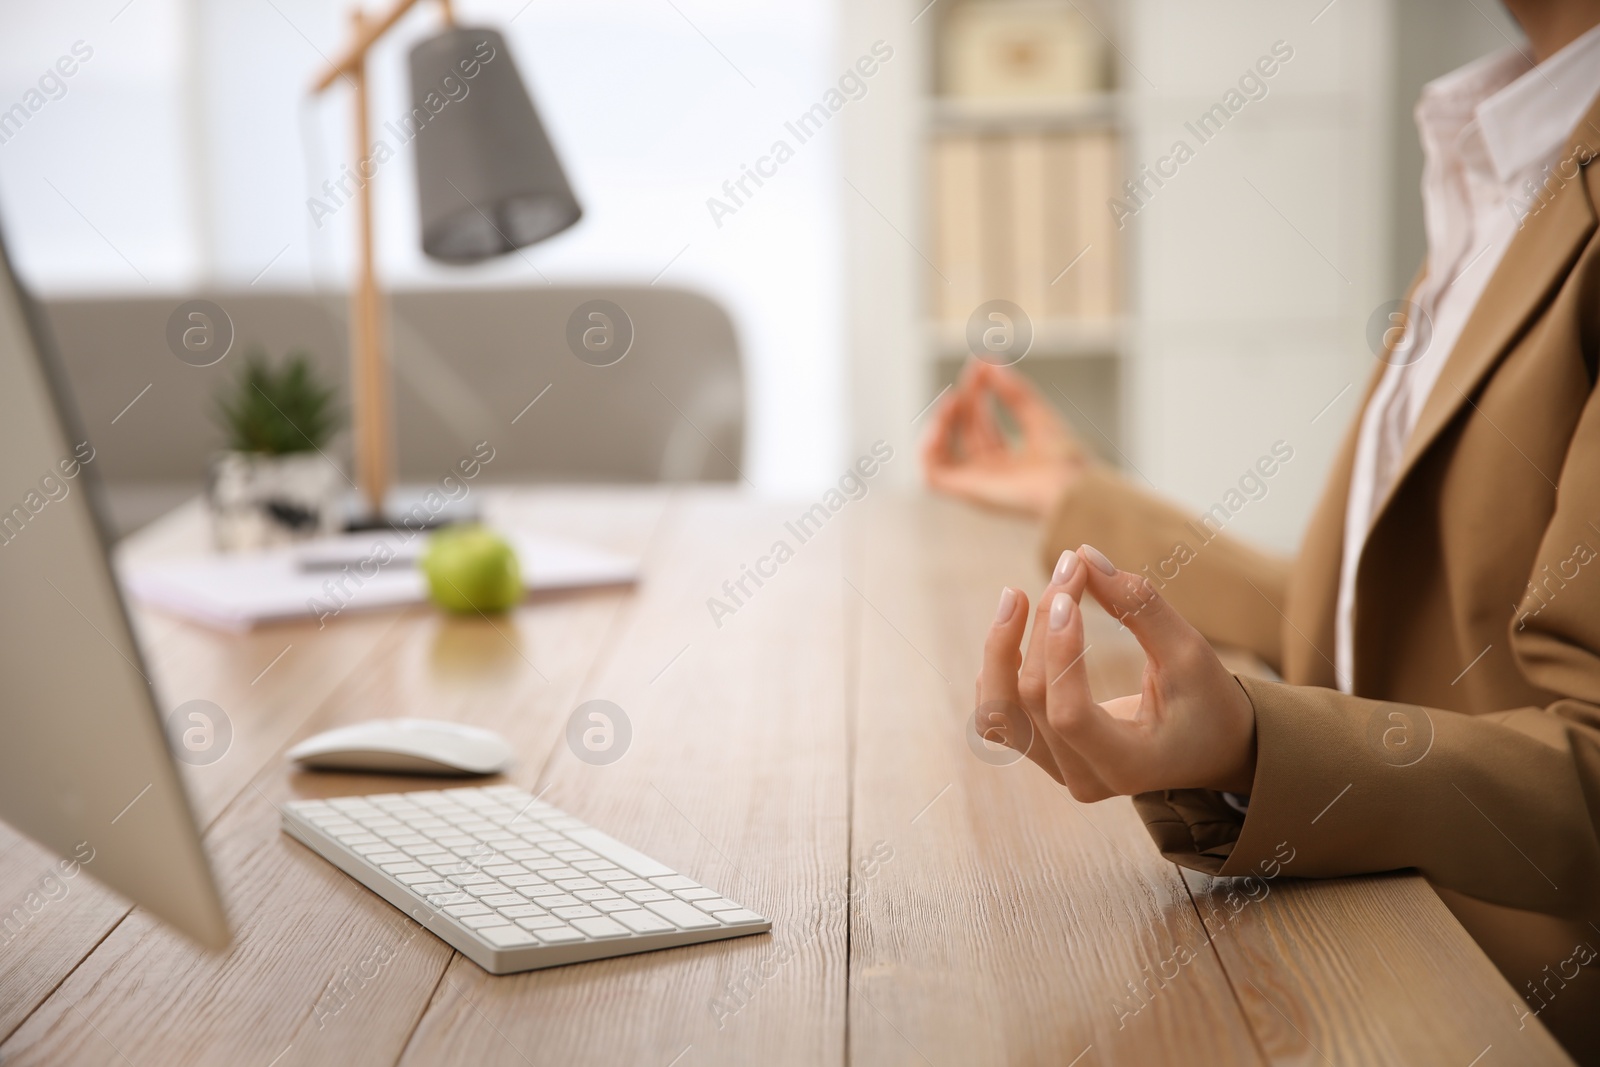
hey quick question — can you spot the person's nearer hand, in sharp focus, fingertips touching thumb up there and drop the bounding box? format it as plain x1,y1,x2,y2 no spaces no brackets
978,545,1256,801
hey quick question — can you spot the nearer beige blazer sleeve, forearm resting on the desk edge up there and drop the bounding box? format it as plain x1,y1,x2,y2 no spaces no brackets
1134,677,1600,920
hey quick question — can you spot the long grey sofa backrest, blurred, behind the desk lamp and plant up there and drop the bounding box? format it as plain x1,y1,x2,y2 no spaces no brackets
43,279,744,491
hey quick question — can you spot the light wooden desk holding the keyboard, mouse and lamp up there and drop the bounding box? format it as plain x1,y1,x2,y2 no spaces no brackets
0,490,1566,1067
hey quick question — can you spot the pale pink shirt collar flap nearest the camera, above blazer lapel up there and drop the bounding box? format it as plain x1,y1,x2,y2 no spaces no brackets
1474,26,1600,182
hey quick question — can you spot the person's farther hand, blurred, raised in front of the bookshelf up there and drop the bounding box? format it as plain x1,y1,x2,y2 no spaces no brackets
922,360,1088,518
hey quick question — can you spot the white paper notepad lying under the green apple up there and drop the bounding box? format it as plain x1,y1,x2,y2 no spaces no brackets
122,533,638,630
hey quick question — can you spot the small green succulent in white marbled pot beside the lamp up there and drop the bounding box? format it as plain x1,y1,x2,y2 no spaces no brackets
206,349,344,552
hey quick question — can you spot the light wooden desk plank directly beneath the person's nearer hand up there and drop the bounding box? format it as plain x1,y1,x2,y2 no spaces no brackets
846,501,1261,1065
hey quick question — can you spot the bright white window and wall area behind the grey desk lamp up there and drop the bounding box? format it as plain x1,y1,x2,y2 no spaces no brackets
0,0,845,491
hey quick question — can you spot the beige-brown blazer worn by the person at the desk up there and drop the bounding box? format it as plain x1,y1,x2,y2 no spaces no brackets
1045,95,1600,1059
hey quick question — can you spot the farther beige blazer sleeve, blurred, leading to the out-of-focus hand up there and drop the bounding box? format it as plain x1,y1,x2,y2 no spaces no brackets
1042,466,1290,670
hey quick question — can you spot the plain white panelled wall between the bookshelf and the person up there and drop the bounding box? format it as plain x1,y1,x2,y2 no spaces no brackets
1123,0,1394,550
